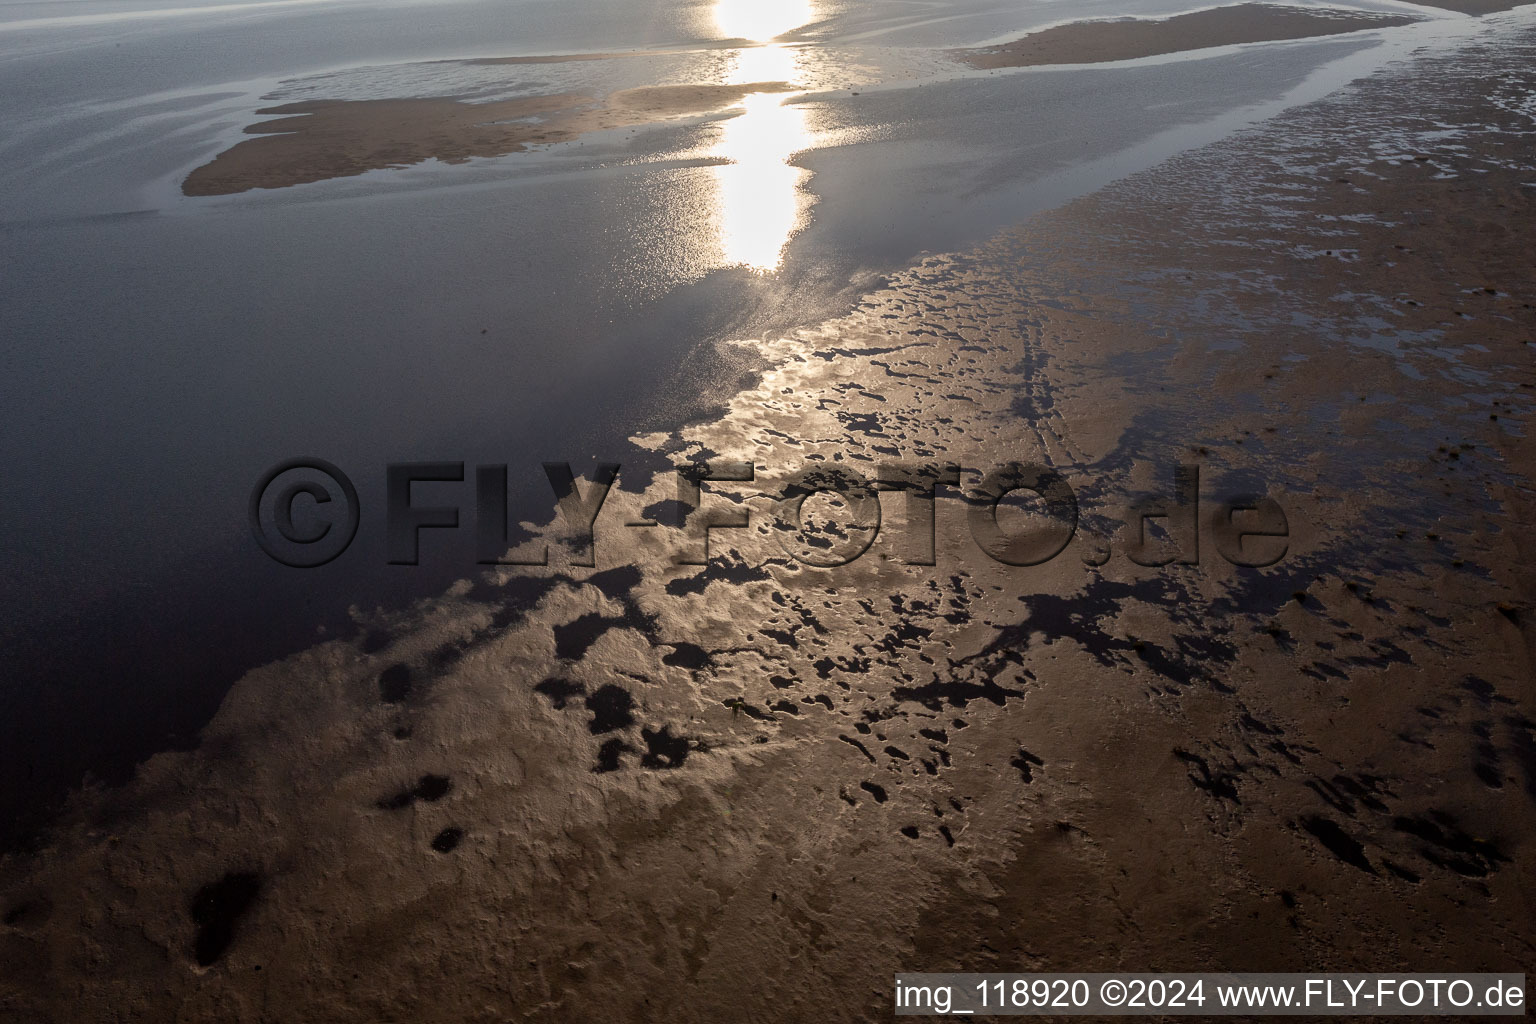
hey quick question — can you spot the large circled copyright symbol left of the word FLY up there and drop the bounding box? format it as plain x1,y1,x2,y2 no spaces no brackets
249,459,358,570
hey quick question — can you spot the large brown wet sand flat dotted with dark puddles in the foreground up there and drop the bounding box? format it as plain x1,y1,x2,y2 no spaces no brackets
0,16,1536,1024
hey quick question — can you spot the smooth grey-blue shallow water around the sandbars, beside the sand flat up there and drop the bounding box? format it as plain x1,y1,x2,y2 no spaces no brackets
0,0,1492,841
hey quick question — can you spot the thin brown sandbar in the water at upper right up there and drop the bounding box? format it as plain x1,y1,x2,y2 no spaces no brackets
955,0,1413,68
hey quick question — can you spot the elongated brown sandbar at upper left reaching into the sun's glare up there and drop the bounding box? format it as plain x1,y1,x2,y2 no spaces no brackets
181,81,793,195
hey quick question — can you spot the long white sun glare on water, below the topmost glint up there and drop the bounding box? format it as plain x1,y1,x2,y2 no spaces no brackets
710,46,811,273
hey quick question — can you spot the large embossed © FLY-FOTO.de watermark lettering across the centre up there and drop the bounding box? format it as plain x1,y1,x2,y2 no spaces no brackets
247,459,1290,568
